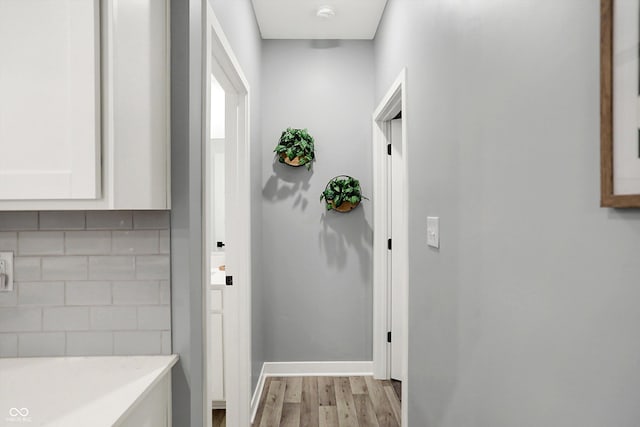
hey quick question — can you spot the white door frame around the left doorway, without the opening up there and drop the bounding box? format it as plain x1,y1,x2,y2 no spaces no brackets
202,1,252,427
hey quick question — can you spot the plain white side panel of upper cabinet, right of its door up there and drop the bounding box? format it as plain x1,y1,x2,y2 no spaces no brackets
107,0,170,209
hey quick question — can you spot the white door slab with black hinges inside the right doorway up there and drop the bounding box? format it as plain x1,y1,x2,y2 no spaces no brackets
389,119,407,380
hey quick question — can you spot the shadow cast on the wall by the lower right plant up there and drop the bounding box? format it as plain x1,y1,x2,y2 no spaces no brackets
318,183,373,283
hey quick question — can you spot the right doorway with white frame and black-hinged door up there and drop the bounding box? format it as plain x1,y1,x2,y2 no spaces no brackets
373,68,409,425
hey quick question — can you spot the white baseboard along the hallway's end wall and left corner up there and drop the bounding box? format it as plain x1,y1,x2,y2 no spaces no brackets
251,361,373,423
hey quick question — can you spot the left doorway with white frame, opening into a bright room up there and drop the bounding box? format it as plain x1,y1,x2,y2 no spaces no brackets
202,3,251,427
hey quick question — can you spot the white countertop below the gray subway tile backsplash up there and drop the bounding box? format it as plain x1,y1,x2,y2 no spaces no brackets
0,355,178,427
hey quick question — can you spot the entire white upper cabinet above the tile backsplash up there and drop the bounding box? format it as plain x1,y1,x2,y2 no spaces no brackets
0,0,170,210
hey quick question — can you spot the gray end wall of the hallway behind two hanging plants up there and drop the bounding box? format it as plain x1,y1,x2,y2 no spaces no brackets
261,40,374,361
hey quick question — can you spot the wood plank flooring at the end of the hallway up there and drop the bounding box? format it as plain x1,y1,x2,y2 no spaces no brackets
253,377,401,427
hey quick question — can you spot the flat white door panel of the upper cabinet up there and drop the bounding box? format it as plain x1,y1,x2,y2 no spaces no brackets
0,0,100,200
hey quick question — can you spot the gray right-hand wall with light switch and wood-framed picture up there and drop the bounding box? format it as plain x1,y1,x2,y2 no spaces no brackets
375,0,640,427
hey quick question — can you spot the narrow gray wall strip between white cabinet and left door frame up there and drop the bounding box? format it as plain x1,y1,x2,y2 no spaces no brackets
171,0,205,427
